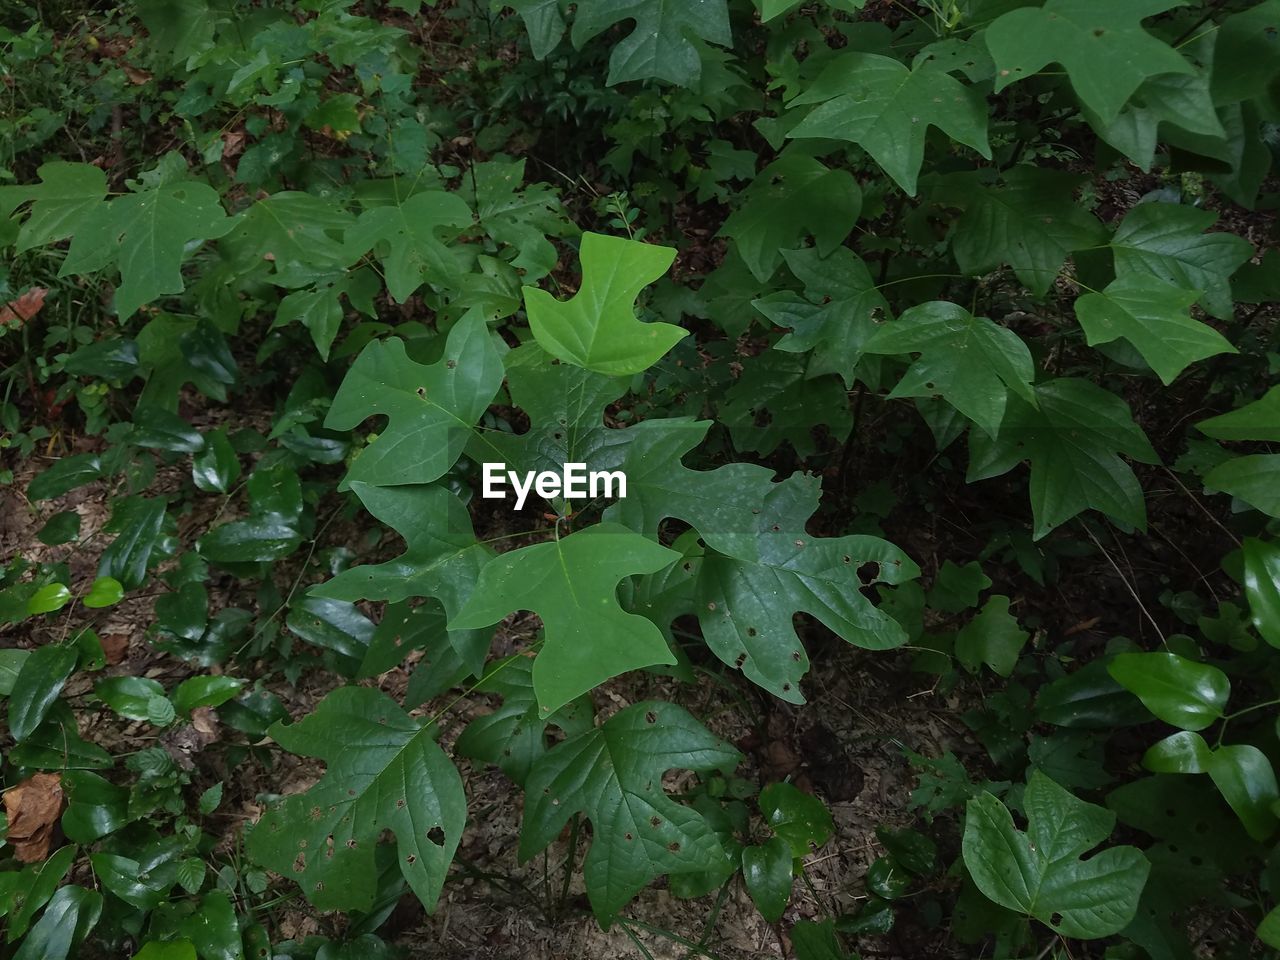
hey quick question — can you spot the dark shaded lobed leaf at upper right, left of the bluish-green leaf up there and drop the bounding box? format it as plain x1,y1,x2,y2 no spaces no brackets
952,166,1106,297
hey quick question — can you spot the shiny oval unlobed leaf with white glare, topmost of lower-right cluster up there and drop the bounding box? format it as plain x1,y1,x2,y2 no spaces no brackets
1107,653,1231,730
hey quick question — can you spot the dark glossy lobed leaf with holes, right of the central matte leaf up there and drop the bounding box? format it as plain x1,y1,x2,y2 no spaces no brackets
698,474,919,703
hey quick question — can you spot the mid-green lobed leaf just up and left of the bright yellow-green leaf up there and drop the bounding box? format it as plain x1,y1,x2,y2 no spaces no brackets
343,189,471,303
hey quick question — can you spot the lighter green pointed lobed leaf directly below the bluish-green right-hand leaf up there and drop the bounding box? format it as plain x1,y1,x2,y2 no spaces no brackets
1075,273,1236,385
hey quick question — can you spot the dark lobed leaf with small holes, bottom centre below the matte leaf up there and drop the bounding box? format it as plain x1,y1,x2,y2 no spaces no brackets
520,701,742,920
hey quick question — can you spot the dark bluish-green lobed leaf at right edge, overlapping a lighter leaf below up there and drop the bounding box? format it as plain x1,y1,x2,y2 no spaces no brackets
1111,204,1253,320
